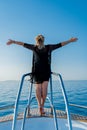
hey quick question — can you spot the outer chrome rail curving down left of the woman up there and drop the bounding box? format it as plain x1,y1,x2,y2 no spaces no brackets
12,73,31,130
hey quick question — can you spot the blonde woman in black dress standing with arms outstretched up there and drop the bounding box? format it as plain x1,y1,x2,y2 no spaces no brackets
7,35,78,115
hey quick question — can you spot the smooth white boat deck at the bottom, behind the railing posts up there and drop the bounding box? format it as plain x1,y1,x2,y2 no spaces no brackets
0,117,87,130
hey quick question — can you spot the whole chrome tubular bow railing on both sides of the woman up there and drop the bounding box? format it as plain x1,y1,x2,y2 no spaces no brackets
12,72,72,130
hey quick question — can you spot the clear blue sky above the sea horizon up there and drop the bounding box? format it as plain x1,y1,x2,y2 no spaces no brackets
0,0,87,81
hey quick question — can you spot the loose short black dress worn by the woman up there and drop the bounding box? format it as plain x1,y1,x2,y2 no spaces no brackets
24,43,61,83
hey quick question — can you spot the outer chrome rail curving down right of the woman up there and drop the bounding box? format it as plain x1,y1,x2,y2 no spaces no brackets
52,72,72,130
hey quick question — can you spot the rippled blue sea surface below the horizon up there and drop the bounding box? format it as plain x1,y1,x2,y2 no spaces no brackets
0,80,87,116
